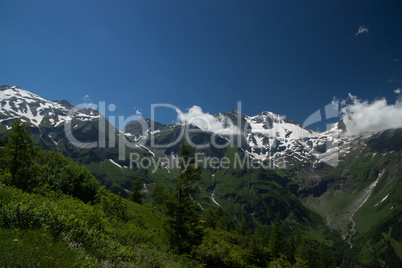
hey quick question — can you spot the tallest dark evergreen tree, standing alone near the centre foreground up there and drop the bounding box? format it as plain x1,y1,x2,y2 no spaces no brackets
174,141,201,253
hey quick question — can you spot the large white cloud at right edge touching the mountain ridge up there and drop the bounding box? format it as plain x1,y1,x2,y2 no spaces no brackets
342,94,402,136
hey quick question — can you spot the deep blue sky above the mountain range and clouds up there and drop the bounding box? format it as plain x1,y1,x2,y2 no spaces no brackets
0,0,402,129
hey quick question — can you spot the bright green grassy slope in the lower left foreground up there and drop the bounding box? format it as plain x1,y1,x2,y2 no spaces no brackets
0,184,199,267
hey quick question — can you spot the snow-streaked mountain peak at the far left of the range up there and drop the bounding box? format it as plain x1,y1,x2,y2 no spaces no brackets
0,86,113,162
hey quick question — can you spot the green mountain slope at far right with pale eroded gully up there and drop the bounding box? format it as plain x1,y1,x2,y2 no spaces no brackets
305,129,402,267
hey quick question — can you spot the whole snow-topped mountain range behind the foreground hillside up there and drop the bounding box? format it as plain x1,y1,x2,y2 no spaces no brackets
0,86,402,267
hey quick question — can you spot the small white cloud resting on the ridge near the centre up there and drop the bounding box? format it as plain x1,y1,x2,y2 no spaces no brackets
178,105,239,134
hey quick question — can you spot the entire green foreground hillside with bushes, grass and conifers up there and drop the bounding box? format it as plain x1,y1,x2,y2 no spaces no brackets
0,121,334,267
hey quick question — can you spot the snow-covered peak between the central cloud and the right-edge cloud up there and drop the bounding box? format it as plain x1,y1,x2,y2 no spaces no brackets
216,110,350,167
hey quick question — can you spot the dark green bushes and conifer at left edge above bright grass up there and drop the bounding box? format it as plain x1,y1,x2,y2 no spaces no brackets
0,120,99,202
